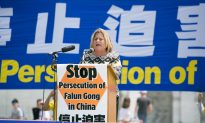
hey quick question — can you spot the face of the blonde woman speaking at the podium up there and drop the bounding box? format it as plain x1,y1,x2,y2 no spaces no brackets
93,33,106,52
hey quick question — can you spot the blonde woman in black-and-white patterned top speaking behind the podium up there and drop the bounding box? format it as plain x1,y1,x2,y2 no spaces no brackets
80,28,122,78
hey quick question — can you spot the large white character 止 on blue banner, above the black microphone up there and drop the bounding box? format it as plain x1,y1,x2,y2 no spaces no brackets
27,3,80,54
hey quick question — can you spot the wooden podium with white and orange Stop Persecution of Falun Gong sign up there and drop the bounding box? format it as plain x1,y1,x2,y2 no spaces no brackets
56,64,118,122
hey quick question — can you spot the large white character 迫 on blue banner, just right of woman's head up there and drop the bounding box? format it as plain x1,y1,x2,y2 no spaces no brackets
104,5,156,57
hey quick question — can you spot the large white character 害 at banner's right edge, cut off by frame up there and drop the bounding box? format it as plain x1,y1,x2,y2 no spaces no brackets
176,4,205,58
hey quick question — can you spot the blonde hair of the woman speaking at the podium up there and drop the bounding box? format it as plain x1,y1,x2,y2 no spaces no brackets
90,28,113,53
